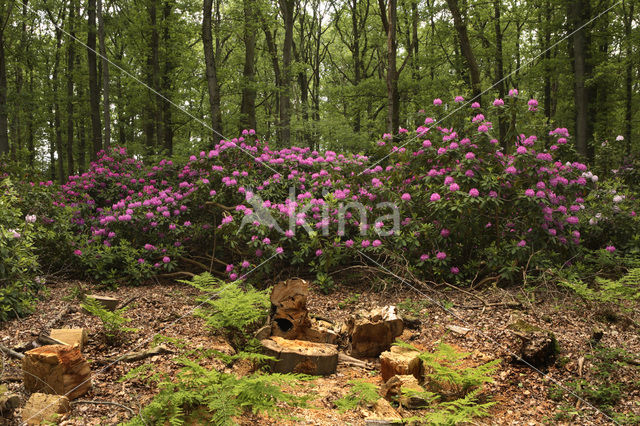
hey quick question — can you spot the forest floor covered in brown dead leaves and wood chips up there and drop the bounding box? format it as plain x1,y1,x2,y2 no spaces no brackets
0,282,640,425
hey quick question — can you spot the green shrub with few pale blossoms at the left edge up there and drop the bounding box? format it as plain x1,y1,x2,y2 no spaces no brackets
0,179,43,322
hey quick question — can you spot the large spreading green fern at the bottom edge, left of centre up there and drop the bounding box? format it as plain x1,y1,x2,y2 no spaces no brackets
128,359,309,426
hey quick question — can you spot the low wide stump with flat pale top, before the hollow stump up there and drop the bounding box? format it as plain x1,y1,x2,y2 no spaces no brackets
261,336,338,376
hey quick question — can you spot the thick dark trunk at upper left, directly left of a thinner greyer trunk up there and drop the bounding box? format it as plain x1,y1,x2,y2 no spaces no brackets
87,0,102,160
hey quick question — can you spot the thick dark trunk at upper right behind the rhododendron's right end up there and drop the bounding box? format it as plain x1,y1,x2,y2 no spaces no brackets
568,0,591,159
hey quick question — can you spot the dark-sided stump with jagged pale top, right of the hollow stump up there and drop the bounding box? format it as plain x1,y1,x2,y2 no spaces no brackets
346,306,404,357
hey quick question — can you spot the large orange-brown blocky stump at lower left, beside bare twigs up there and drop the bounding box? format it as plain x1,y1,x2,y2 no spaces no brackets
22,345,91,399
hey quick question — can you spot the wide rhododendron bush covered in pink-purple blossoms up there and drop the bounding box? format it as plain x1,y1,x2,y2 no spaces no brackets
30,94,638,281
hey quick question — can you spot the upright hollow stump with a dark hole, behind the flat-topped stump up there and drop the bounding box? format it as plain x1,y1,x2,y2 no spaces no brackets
268,278,338,344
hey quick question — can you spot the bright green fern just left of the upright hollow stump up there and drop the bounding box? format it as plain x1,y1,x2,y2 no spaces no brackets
182,273,271,349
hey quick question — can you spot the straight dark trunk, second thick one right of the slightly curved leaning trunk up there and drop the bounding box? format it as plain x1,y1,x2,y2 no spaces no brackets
278,0,296,146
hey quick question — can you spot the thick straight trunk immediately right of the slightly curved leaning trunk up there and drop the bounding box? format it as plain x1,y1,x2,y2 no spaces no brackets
240,0,257,130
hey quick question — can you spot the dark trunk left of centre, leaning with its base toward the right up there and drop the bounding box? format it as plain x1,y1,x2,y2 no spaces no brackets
202,0,222,140
